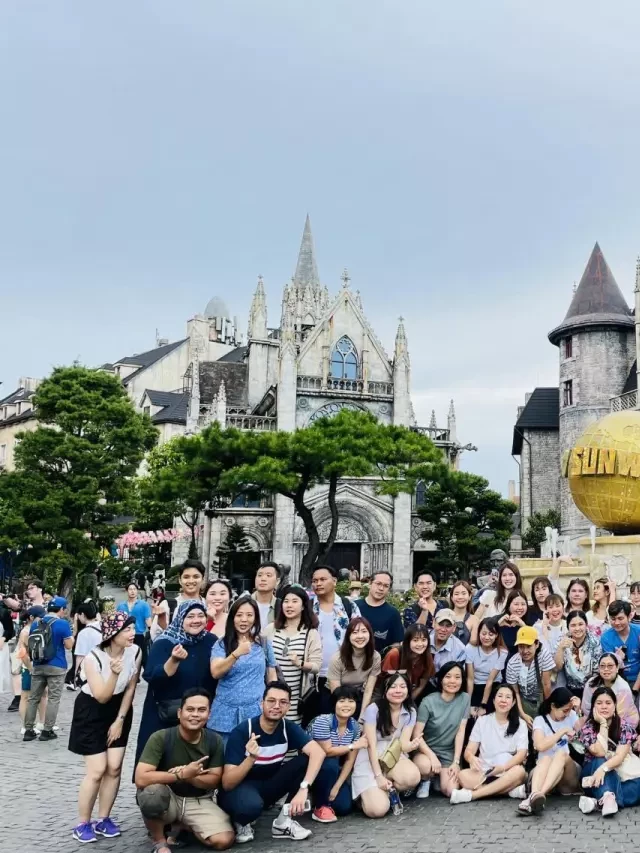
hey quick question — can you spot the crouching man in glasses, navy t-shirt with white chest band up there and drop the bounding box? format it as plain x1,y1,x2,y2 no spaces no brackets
218,681,335,844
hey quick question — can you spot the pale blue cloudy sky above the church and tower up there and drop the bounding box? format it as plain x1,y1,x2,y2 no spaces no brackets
0,0,640,493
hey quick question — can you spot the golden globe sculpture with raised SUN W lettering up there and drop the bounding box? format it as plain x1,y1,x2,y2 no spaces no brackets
562,410,640,534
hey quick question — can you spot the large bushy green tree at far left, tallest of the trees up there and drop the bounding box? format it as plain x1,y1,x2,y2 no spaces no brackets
0,365,157,595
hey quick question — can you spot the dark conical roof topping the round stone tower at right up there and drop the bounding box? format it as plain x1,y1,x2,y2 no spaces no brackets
549,243,633,346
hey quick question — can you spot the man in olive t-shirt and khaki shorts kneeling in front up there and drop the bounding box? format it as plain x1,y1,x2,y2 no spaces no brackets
135,687,235,853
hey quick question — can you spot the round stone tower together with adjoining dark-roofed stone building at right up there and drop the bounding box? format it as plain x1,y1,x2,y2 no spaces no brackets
513,243,640,553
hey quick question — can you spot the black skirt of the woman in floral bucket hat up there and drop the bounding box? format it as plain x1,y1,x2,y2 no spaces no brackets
69,691,133,755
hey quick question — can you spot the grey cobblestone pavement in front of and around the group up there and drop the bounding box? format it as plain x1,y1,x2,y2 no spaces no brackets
5,683,640,853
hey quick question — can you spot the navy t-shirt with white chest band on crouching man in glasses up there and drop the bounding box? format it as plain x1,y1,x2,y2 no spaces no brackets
224,716,311,781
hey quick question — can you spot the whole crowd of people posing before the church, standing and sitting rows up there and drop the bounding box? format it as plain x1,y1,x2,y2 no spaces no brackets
0,560,640,853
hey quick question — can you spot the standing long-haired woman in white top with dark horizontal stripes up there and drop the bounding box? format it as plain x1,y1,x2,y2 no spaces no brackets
264,584,322,725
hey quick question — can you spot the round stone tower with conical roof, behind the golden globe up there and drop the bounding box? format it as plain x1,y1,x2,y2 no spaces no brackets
549,243,635,541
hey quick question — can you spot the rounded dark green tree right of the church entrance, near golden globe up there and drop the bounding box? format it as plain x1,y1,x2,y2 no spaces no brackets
418,470,516,577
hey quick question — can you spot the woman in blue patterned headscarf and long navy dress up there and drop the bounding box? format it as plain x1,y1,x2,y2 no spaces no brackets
136,600,218,763
